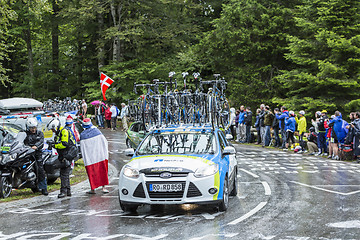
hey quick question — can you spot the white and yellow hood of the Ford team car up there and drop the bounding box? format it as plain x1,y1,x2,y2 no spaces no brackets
127,155,214,172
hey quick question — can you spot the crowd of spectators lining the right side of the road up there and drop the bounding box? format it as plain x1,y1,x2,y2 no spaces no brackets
229,104,360,162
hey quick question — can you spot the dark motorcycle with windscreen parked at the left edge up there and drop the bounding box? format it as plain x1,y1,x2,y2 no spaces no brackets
0,132,38,198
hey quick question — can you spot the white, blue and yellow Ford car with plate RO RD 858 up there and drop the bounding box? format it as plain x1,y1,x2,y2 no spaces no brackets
119,126,237,211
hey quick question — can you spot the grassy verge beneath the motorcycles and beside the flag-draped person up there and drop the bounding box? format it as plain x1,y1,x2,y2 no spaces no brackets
0,159,88,202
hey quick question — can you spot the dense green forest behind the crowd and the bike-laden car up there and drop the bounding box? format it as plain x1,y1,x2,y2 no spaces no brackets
0,0,360,117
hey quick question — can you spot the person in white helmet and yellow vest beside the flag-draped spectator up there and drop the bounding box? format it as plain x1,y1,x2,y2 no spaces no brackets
47,118,78,198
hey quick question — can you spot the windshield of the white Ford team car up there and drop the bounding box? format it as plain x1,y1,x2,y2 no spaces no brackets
137,132,216,155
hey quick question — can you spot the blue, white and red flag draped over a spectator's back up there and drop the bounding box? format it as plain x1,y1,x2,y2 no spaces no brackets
80,126,109,190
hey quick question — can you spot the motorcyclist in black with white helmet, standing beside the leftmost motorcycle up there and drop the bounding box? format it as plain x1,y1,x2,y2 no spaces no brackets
24,118,48,196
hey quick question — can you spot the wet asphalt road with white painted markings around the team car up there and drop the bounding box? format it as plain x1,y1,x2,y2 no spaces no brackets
0,130,360,240
